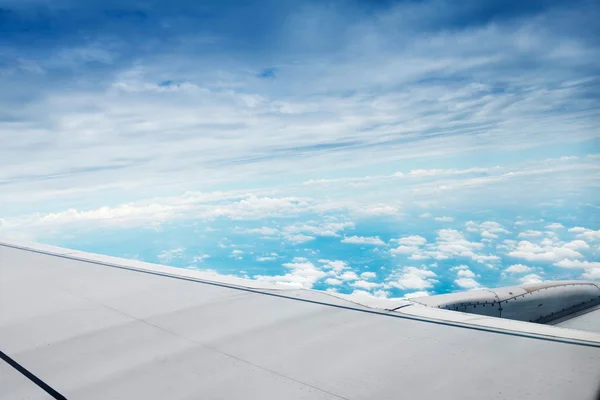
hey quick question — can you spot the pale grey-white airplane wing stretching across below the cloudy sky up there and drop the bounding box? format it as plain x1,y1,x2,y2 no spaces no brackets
0,242,600,400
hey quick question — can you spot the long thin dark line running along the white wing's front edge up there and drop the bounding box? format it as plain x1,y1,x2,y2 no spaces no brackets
0,243,600,348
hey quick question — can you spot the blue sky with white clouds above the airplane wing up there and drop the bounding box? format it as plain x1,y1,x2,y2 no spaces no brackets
0,0,600,298
